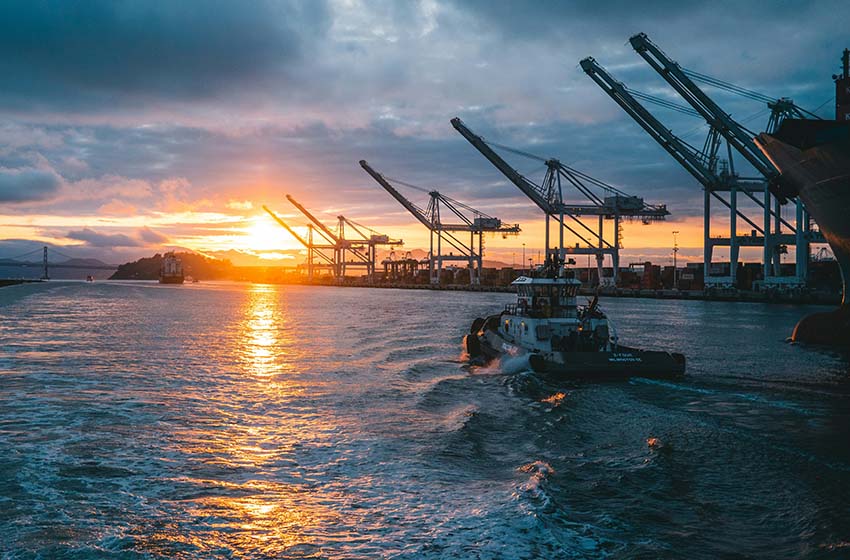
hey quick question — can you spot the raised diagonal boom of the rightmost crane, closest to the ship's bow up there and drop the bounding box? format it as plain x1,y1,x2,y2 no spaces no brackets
629,33,778,179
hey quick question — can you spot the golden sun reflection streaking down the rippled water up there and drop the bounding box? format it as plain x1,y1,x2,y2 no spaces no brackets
145,285,341,557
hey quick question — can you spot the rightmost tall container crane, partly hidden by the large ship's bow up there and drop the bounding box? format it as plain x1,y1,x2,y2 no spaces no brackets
629,33,824,285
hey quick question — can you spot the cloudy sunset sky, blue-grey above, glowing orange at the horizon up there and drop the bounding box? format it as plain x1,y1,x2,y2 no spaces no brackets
0,0,850,262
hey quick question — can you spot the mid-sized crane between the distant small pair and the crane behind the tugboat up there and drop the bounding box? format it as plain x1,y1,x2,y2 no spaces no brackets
360,160,520,285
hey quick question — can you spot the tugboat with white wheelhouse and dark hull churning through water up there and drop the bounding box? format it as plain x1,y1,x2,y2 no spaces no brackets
464,261,685,379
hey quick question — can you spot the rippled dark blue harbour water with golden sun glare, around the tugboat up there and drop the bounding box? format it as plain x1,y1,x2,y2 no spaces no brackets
0,282,850,558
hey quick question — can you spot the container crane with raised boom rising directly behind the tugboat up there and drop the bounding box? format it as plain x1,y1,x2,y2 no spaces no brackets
451,117,670,285
